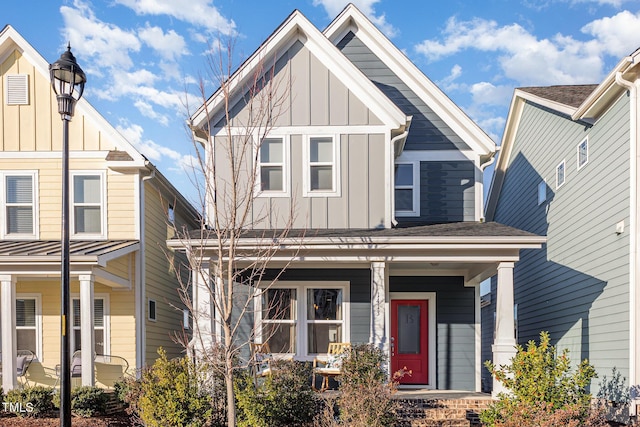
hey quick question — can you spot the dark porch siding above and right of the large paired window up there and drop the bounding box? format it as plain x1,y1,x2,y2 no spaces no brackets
262,268,371,343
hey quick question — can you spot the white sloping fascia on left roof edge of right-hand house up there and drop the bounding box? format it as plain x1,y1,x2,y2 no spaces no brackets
485,93,525,221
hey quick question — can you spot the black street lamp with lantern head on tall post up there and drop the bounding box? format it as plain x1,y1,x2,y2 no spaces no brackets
49,45,87,427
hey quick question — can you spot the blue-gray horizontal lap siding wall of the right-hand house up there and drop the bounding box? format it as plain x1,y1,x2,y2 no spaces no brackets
492,96,630,384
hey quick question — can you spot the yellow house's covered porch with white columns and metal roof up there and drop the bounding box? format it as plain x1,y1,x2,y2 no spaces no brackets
0,240,140,392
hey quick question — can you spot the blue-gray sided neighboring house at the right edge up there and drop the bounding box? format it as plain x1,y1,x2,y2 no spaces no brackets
483,51,640,407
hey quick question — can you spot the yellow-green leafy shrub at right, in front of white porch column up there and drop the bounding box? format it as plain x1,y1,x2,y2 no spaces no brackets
480,332,596,426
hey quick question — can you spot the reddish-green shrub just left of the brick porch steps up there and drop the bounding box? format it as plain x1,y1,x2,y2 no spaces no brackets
332,344,397,427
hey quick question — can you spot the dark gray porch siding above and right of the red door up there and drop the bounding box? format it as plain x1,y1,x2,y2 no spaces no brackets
389,276,476,390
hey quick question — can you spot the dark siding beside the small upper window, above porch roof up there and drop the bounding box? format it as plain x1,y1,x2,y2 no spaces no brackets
396,161,476,225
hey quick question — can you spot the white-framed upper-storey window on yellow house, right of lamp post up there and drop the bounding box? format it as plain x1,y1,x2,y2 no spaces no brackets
71,172,106,237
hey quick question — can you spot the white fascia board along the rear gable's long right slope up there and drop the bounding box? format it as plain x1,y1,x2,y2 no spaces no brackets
324,4,496,155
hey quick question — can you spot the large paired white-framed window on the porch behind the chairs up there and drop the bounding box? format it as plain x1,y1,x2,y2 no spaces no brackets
258,282,349,359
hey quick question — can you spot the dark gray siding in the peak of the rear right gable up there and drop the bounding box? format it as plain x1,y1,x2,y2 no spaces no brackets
337,32,469,150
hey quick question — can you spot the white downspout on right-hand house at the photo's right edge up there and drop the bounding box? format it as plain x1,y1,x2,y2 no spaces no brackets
616,71,640,415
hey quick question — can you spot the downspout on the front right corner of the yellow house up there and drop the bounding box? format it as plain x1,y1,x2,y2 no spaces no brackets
135,169,156,372
